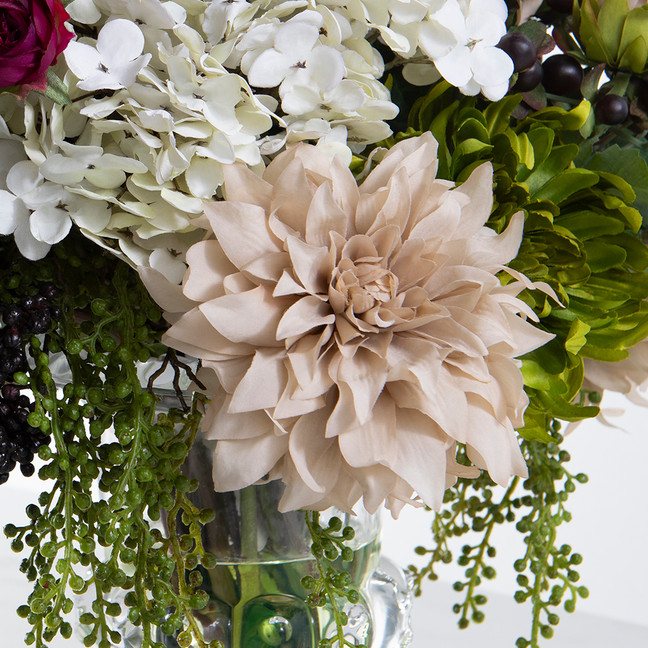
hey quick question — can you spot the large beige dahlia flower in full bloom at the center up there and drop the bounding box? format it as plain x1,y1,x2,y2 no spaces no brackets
156,134,550,514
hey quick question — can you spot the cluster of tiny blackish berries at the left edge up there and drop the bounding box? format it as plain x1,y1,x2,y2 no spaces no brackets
0,284,62,484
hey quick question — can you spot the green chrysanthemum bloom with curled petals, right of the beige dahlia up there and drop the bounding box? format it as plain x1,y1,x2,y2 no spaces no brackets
410,83,648,441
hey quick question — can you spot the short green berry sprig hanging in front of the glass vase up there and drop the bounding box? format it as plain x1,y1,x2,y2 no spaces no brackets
302,511,367,648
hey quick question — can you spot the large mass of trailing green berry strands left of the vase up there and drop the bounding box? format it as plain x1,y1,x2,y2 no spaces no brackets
0,236,219,648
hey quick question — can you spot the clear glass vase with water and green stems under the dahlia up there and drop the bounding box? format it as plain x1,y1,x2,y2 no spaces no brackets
158,442,411,648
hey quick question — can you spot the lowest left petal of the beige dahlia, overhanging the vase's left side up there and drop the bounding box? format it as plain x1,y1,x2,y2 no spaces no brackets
213,434,288,491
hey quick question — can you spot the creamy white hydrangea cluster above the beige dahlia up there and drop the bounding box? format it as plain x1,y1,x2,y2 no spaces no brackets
0,0,512,282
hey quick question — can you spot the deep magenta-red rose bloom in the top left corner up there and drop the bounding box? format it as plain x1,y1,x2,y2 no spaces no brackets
0,0,73,95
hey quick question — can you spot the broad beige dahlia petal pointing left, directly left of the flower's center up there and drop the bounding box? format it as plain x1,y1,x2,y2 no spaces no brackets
199,286,291,347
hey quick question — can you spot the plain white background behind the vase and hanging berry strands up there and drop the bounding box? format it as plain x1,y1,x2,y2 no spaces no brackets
0,394,648,648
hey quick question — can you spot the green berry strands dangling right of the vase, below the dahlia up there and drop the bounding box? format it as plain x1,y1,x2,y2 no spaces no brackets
409,423,588,648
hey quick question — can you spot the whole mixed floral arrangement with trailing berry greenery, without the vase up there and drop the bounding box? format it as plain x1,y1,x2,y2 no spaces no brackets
0,0,648,648
